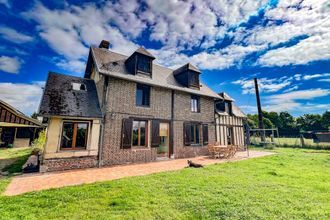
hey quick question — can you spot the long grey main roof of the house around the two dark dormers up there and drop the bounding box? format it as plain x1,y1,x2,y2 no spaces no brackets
91,47,222,99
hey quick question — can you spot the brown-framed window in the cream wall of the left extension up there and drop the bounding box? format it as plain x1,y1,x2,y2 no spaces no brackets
61,122,88,150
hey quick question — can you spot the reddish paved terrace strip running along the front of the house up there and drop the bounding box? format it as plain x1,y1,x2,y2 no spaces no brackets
4,151,273,196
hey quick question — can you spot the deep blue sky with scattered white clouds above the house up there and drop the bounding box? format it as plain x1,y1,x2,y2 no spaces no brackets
0,0,330,116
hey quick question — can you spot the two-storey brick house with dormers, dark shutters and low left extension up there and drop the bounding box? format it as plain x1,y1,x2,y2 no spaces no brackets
39,41,244,171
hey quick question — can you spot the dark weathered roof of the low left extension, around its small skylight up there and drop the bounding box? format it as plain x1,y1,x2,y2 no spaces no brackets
39,72,102,118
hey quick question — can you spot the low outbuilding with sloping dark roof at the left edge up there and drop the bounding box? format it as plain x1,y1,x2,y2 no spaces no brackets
0,100,43,148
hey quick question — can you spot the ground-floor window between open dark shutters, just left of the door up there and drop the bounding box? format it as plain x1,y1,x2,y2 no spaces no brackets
132,120,147,147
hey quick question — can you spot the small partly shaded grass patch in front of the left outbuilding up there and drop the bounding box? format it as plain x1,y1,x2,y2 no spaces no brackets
0,148,32,173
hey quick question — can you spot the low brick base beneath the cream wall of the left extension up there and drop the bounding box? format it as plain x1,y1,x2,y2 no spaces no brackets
40,156,97,172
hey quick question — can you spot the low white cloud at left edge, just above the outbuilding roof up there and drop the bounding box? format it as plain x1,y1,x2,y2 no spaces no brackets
0,82,44,115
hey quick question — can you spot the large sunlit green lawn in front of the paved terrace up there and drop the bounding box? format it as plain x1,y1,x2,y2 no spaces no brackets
0,148,330,219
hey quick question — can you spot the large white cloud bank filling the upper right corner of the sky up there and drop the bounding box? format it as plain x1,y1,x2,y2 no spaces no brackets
258,0,330,66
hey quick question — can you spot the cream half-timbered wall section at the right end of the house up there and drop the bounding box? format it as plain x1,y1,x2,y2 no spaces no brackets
216,115,245,147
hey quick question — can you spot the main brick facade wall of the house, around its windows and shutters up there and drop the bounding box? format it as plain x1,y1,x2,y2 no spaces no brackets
102,78,215,165
